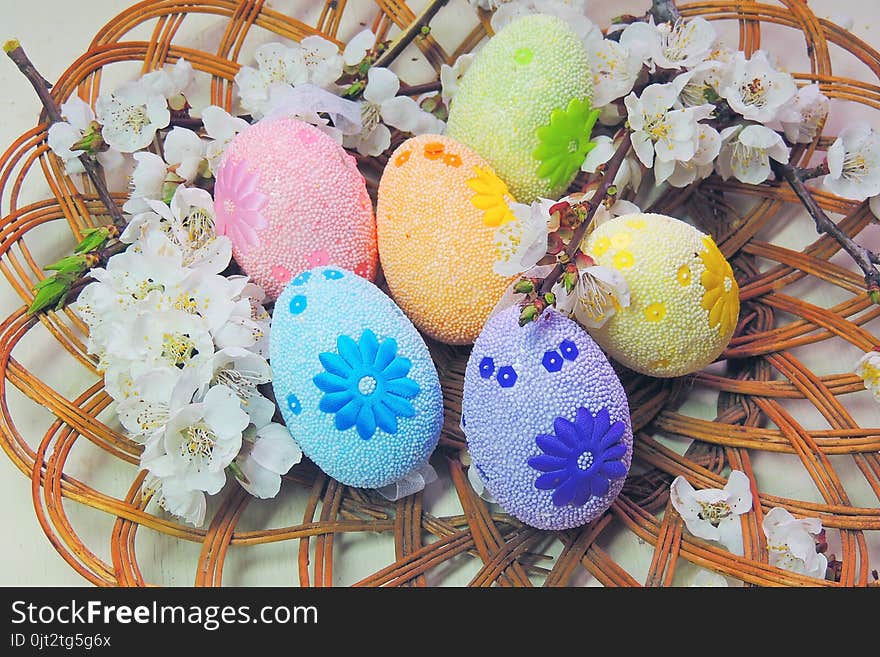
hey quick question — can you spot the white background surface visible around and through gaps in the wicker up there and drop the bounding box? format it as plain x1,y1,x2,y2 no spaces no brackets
0,0,880,586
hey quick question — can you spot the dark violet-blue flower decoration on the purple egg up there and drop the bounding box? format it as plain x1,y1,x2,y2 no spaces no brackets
529,408,627,506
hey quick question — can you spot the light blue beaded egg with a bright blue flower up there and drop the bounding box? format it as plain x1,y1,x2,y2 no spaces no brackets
269,267,443,488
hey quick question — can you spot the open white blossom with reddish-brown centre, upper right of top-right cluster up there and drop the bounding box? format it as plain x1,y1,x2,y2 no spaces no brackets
721,50,797,123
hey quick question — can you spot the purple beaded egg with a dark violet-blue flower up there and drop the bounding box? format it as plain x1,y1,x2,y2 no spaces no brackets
462,306,633,529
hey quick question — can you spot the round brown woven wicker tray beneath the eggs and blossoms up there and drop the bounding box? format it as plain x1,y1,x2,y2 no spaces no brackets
0,0,880,586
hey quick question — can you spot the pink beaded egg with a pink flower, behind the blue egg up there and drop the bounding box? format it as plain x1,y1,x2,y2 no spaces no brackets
214,118,378,299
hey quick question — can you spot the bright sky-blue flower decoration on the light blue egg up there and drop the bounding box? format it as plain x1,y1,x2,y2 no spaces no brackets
312,329,420,440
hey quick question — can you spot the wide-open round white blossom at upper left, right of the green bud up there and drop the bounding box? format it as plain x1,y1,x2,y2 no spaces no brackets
95,82,171,153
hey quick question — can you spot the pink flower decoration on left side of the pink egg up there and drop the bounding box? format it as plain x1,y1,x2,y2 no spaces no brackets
214,160,269,251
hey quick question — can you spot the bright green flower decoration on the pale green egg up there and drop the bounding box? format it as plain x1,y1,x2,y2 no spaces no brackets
532,98,600,188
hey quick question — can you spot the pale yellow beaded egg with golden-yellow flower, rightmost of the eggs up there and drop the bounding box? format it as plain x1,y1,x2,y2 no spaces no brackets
586,214,739,377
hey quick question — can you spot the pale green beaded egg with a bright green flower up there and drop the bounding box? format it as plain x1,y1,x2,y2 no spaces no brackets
447,14,597,203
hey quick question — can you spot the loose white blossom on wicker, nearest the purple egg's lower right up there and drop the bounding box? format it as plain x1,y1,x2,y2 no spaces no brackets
669,470,752,554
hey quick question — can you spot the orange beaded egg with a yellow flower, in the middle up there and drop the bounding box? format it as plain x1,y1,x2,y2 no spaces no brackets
376,135,513,344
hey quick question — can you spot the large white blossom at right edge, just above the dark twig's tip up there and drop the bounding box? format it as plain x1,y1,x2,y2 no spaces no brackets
825,122,880,201
